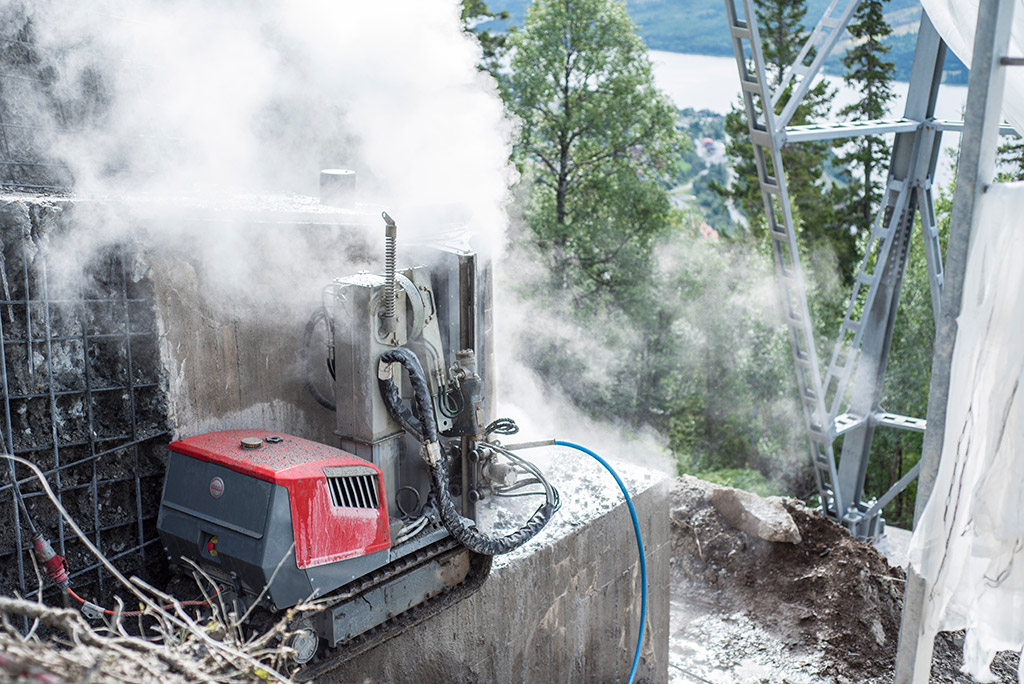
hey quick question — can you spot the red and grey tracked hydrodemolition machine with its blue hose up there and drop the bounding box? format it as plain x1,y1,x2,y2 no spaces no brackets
12,213,646,682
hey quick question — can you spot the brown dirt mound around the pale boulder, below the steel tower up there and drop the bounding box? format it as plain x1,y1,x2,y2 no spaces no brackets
672,476,1016,682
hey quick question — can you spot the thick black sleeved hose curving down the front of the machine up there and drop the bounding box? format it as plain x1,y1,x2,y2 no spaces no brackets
377,347,556,556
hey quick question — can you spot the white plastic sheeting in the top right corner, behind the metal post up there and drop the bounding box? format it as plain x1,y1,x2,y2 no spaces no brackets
921,0,1024,132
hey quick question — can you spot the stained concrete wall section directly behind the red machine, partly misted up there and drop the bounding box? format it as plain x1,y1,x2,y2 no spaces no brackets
145,208,383,443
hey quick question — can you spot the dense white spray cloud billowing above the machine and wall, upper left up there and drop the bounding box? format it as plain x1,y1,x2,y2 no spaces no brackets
7,0,511,286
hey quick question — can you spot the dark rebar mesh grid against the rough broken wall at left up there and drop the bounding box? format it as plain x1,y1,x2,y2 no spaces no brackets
0,230,168,597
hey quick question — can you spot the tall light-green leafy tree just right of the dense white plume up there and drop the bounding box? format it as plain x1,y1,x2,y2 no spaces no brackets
504,0,683,303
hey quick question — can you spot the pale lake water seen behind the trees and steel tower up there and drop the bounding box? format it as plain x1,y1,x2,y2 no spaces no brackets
650,50,967,185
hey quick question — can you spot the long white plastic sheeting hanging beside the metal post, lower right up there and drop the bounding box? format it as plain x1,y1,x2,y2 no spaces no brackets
910,183,1024,682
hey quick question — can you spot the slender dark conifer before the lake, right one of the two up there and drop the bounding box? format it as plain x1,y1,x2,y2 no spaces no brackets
840,0,896,233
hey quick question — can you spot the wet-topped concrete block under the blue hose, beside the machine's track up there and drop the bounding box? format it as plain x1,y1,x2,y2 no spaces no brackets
319,457,672,684
